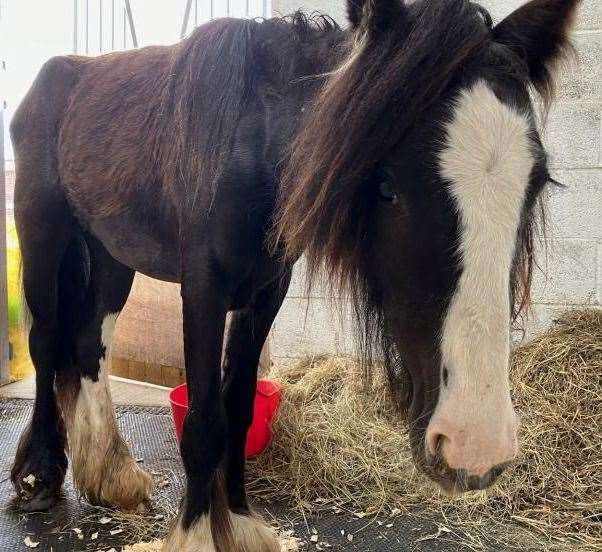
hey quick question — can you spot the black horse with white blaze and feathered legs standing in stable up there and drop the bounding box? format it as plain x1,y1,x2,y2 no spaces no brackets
10,0,579,552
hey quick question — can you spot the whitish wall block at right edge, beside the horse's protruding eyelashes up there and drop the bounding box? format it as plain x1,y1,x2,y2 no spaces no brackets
547,169,602,240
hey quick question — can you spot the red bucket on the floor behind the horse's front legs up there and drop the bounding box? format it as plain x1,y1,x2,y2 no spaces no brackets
169,380,281,458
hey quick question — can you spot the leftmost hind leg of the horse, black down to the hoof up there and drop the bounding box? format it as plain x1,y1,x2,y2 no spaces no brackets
11,184,73,511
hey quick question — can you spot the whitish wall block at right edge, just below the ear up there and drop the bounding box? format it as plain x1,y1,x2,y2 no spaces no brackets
543,102,600,169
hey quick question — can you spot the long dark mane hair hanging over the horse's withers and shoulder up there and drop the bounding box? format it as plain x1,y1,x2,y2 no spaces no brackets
166,11,340,213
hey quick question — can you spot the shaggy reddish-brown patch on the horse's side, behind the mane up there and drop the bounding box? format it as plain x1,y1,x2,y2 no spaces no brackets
57,47,175,218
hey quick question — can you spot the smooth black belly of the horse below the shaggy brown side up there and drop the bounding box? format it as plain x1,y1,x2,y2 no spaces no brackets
90,216,180,282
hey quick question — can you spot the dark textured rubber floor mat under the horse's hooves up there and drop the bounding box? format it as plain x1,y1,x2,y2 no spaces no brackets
0,399,527,552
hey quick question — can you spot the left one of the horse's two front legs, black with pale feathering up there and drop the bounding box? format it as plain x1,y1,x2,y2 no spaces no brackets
165,252,234,552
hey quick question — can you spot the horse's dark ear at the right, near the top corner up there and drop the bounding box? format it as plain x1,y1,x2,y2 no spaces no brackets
493,0,581,91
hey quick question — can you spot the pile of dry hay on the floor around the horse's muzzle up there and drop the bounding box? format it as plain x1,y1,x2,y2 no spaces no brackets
249,310,602,550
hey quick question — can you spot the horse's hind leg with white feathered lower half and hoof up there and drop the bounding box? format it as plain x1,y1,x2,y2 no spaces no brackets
57,238,152,510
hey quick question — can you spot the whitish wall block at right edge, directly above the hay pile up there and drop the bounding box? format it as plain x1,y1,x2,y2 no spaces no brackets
532,240,598,305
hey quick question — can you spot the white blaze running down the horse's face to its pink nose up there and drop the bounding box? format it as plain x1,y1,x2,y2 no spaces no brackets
426,81,535,476
